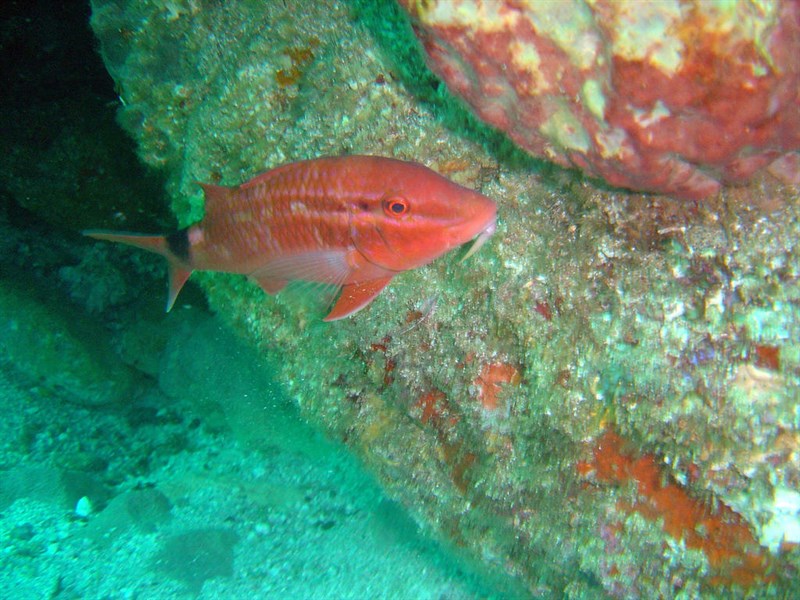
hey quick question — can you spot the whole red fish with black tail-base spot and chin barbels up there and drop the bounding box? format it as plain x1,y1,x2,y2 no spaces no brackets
84,156,496,321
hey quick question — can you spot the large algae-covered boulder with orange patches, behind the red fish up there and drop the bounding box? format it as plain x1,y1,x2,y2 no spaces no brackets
92,0,800,597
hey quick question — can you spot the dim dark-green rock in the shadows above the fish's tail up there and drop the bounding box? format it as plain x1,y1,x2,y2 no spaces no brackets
0,98,168,230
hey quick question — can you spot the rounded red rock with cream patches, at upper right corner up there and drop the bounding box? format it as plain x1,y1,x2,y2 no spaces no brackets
399,0,800,198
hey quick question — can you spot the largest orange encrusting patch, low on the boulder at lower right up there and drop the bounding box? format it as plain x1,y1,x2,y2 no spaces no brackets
577,431,773,587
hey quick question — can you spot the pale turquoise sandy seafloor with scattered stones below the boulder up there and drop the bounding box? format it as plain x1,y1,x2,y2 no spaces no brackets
0,316,491,600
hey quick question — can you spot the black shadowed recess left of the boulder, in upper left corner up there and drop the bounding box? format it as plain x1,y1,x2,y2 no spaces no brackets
0,3,168,230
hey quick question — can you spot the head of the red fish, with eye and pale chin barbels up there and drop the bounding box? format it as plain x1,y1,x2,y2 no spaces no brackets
350,163,497,271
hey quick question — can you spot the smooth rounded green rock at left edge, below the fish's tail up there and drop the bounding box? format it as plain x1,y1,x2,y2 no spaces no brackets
0,279,134,406
